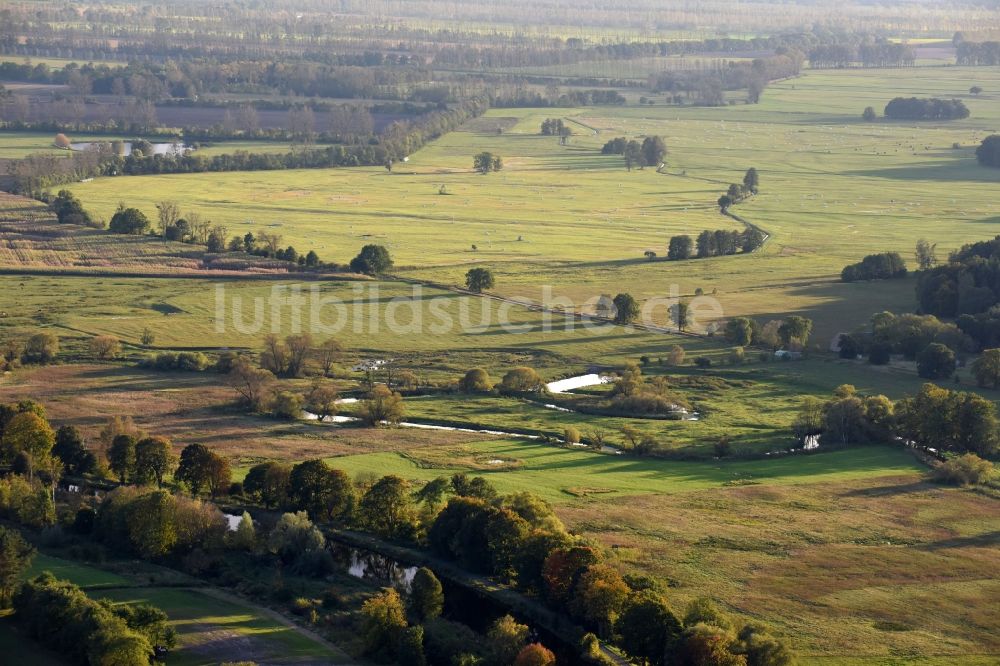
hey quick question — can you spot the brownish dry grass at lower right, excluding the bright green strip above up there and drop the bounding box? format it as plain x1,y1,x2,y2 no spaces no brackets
560,475,1000,663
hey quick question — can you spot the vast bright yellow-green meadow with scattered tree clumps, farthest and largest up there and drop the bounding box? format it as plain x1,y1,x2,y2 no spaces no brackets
60,67,1000,347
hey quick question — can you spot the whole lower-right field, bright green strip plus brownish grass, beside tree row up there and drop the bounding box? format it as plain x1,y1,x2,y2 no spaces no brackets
328,440,1000,665
